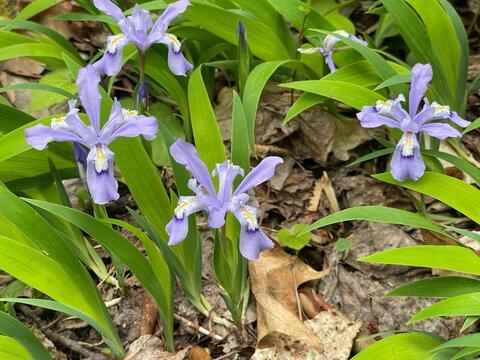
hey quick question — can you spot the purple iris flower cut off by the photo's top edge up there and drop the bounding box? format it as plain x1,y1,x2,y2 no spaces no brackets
94,0,192,76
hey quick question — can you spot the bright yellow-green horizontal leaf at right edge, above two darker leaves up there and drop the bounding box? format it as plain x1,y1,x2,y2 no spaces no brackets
358,245,480,275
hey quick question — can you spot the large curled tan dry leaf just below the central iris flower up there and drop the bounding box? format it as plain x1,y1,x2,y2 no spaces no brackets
248,247,325,351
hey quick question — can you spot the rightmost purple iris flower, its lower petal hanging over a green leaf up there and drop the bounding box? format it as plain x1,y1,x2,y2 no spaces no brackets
357,64,470,181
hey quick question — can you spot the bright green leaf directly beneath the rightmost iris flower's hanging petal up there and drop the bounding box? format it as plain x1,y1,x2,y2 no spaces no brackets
373,172,480,224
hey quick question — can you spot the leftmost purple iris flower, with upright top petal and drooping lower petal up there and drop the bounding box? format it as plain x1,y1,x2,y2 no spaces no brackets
25,65,158,204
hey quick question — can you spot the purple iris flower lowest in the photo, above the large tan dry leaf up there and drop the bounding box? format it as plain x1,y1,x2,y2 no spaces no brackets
166,139,283,260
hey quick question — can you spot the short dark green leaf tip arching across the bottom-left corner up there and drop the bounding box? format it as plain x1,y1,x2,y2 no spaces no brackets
0,311,52,360
